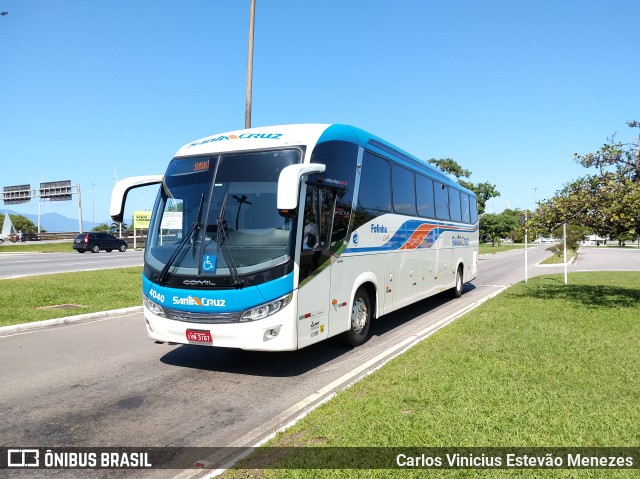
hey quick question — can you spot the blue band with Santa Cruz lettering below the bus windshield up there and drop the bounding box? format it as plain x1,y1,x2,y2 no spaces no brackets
142,273,293,313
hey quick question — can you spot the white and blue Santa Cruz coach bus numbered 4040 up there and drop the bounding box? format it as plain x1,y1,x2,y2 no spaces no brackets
111,125,478,351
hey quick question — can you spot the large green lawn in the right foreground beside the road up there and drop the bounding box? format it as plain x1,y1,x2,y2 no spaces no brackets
224,272,640,478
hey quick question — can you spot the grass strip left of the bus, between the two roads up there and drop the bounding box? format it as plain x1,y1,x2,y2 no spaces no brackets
0,266,142,326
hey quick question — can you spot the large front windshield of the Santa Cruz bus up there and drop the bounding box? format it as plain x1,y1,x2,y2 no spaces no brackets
145,149,302,287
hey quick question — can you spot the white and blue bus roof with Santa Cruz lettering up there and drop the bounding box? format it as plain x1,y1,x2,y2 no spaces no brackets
175,124,474,195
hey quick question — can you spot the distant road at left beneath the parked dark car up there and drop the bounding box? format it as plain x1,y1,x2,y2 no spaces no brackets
0,249,144,279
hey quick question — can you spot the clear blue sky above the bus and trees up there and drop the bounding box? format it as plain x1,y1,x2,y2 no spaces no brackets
0,0,640,224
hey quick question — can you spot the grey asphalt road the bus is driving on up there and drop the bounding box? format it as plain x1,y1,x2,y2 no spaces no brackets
0,248,640,478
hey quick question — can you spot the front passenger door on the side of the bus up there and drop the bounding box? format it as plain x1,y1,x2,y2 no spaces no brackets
297,184,336,348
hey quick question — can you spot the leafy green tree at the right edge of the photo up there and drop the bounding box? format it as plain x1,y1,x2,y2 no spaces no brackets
533,121,640,243
